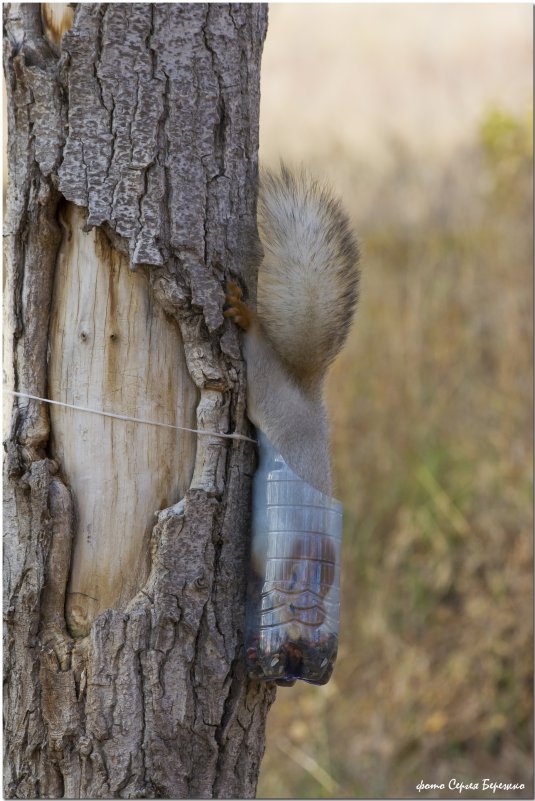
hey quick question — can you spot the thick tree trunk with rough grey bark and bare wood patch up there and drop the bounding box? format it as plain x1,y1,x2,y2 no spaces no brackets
4,3,274,798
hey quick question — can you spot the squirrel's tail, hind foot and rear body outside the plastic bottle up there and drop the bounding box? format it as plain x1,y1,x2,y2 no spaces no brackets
224,165,359,495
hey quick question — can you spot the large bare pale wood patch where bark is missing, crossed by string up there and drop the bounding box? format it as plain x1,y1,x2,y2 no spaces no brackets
48,204,197,636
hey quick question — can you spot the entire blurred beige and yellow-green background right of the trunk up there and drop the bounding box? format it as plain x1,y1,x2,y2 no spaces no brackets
258,4,533,798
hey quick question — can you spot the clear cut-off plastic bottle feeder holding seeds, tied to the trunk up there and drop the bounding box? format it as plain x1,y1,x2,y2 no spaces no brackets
245,431,342,686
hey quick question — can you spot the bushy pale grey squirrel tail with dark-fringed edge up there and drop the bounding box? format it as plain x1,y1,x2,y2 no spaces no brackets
257,165,359,388
